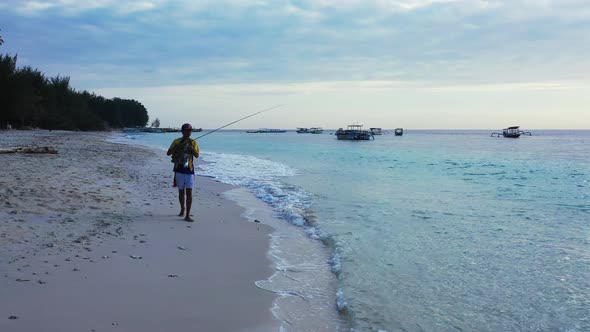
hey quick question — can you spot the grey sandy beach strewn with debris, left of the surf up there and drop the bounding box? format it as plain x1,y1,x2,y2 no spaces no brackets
0,131,279,331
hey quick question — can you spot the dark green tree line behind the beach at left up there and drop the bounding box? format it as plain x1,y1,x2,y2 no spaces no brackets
0,36,148,130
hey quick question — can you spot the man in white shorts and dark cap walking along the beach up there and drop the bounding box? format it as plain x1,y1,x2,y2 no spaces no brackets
166,123,199,221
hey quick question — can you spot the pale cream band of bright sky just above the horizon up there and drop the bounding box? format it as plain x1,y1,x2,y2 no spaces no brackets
93,81,590,129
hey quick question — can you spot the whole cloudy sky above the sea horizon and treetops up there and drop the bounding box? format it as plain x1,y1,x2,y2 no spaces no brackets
0,0,590,129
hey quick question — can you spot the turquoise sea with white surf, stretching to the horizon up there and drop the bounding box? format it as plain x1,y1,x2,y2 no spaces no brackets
126,131,590,331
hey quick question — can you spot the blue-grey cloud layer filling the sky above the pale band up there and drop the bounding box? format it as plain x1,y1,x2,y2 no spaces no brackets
0,0,590,88
